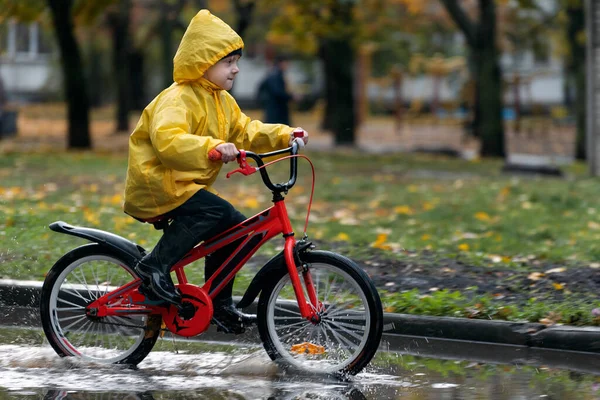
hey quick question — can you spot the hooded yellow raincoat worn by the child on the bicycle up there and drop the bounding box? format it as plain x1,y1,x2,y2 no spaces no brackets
125,10,293,219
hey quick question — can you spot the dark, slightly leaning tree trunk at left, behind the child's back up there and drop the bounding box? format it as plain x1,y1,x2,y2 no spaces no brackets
48,0,91,149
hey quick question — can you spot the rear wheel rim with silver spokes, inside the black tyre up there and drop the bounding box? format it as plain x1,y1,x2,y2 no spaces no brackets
49,255,147,364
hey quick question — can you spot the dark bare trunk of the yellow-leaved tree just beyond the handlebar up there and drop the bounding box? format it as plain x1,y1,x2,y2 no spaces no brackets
321,39,355,145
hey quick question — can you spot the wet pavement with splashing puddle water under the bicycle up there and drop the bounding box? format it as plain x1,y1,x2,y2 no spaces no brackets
0,328,600,400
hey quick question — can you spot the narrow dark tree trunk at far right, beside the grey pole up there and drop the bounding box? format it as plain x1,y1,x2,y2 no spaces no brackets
566,4,586,160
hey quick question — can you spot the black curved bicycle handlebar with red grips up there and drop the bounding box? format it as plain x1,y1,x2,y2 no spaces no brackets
208,130,304,193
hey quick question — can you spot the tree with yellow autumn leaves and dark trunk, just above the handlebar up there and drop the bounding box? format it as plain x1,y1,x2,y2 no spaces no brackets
266,0,385,144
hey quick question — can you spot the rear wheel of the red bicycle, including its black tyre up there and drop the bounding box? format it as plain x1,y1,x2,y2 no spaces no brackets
40,244,162,365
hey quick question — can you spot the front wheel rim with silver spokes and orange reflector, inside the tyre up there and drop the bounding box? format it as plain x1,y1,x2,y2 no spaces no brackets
267,263,371,373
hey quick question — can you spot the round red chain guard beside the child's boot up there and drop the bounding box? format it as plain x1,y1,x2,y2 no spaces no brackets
163,284,213,337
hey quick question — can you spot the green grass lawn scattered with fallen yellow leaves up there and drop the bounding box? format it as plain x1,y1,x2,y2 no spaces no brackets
0,150,600,323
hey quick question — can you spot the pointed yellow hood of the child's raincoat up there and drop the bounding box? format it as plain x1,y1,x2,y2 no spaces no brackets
173,10,244,83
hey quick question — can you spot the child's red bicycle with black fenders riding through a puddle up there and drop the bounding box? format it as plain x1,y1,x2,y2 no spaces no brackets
40,138,383,374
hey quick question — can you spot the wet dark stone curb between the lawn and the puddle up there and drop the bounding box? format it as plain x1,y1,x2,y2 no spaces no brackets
0,279,600,353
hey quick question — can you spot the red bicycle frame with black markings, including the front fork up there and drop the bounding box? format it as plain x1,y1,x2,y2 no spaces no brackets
87,144,319,322
